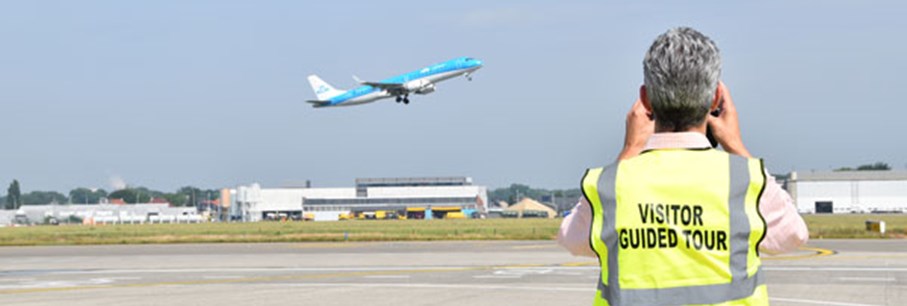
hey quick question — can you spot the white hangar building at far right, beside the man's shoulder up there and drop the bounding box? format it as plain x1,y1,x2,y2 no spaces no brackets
787,171,907,213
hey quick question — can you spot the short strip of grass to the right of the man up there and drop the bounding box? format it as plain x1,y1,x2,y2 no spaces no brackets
803,214,907,239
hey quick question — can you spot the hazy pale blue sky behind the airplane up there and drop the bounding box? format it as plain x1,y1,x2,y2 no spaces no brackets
0,1,907,193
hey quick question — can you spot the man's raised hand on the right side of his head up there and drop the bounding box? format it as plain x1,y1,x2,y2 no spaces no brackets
706,81,752,157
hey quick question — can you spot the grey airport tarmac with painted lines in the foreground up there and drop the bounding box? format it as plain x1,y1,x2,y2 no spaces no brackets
0,240,907,306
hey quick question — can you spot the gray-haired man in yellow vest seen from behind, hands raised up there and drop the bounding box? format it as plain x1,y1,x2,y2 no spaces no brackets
558,28,808,305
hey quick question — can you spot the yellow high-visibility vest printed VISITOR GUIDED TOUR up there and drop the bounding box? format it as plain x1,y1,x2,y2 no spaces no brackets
582,149,768,305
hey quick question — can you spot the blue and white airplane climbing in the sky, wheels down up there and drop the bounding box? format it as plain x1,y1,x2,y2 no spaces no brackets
306,57,482,107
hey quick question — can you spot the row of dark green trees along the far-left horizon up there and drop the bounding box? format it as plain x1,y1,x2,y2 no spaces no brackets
0,180,220,209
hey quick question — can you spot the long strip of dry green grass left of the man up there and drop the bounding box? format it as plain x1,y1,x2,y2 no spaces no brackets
0,219,560,246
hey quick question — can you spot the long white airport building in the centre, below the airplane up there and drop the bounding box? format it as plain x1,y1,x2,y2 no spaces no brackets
231,177,488,222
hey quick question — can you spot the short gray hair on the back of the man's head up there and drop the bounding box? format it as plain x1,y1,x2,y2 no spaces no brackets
643,27,721,132
